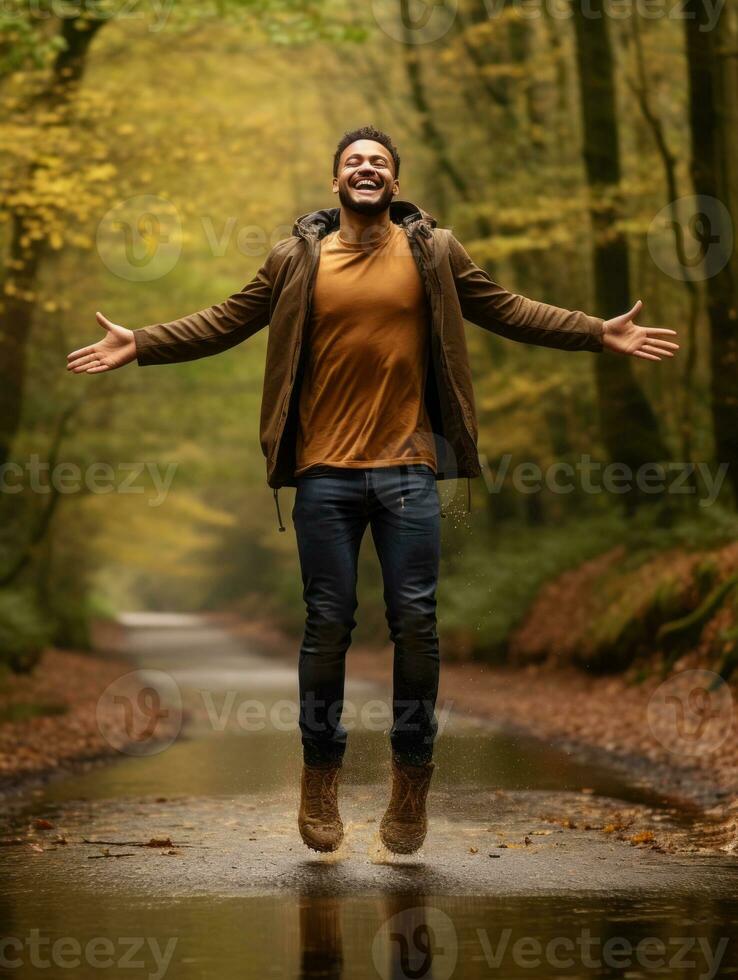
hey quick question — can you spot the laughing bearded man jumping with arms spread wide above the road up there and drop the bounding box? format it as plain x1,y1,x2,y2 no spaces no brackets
68,126,678,854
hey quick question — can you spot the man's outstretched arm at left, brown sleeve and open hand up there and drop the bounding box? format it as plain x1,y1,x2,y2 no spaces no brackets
67,253,273,374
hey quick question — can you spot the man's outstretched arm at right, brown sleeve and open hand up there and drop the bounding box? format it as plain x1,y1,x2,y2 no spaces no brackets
449,234,679,361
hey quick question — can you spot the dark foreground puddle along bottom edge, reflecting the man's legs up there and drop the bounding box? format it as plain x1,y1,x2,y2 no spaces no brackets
0,891,738,980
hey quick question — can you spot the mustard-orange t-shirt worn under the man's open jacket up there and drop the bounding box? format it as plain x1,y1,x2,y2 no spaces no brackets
295,223,436,475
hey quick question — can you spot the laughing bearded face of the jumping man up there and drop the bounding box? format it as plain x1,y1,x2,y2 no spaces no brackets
333,140,400,214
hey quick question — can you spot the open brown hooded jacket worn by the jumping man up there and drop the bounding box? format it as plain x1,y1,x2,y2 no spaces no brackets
134,201,603,488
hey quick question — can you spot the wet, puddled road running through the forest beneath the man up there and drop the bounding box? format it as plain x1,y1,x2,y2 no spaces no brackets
0,615,738,980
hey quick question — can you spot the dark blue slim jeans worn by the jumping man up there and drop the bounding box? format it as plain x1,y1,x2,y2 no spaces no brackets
292,464,440,765
